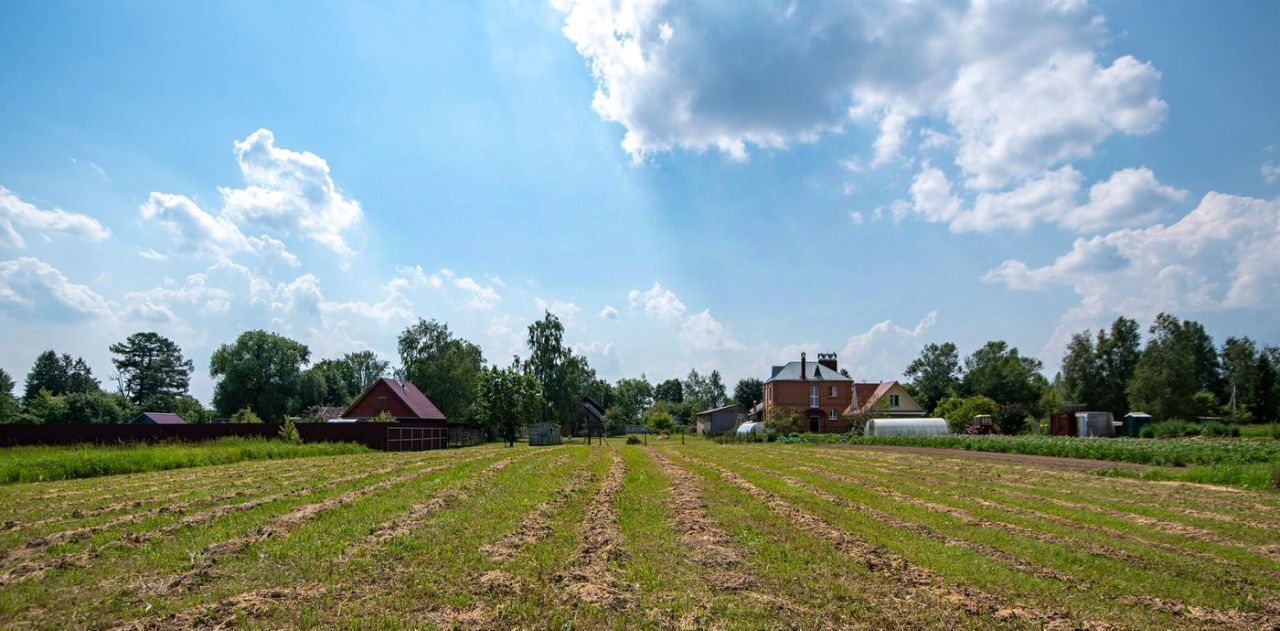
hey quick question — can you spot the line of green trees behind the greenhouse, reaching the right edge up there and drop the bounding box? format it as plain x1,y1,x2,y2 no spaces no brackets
904,314,1280,433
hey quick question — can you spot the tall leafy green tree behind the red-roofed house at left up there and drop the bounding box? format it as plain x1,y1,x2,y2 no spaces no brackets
399,319,484,422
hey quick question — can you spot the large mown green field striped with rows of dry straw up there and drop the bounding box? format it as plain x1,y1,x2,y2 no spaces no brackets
0,439,1280,630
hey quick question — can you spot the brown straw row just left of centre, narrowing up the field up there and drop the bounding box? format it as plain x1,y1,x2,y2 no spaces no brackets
556,452,635,608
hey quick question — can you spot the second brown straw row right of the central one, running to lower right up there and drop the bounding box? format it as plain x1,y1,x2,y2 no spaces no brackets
680,447,1108,630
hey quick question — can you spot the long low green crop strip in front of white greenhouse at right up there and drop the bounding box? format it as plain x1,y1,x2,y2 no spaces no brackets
849,435,1280,467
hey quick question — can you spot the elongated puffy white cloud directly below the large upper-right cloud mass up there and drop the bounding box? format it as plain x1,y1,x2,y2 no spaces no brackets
892,164,1188,233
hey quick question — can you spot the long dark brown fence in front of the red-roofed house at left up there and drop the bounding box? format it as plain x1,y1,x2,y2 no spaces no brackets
0,422,477,451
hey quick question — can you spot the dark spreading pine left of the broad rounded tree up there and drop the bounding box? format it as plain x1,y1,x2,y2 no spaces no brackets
110,331,195,404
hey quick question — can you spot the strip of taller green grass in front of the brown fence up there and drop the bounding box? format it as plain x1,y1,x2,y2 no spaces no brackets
0,438,369,484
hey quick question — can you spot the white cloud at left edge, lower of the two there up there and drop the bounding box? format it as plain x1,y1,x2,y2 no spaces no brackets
0,256,111,320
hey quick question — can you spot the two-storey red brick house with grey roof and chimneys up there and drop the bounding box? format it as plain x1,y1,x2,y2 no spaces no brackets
762,353,854,434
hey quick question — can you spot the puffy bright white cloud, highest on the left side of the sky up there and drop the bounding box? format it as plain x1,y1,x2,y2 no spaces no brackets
219,129,364,256
